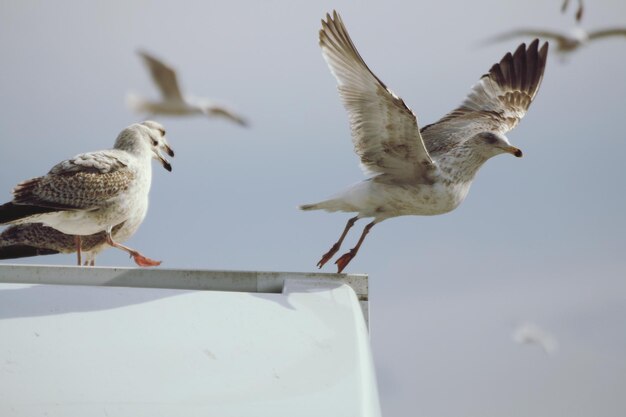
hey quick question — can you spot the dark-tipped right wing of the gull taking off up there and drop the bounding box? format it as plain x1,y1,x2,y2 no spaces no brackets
422,39,548,154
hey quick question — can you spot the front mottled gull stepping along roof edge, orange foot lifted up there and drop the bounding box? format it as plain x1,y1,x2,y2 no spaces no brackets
0,121,174,266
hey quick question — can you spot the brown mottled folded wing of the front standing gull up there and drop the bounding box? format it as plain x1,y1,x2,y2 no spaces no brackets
13,151,135,210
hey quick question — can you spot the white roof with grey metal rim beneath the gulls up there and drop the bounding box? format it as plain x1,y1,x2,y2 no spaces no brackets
0,265,380,417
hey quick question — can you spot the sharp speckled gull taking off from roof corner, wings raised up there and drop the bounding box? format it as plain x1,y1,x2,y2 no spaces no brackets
300,12,548,272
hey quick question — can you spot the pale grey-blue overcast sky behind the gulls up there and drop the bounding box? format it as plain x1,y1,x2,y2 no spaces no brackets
0,0,626,417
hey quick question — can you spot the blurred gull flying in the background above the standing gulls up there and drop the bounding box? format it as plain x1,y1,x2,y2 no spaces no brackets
127,51,248,126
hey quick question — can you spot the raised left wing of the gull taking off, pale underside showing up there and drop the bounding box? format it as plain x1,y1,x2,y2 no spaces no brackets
319,12,432,179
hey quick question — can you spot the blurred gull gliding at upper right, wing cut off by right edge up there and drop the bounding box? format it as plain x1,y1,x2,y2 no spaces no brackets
487,27,626,53
